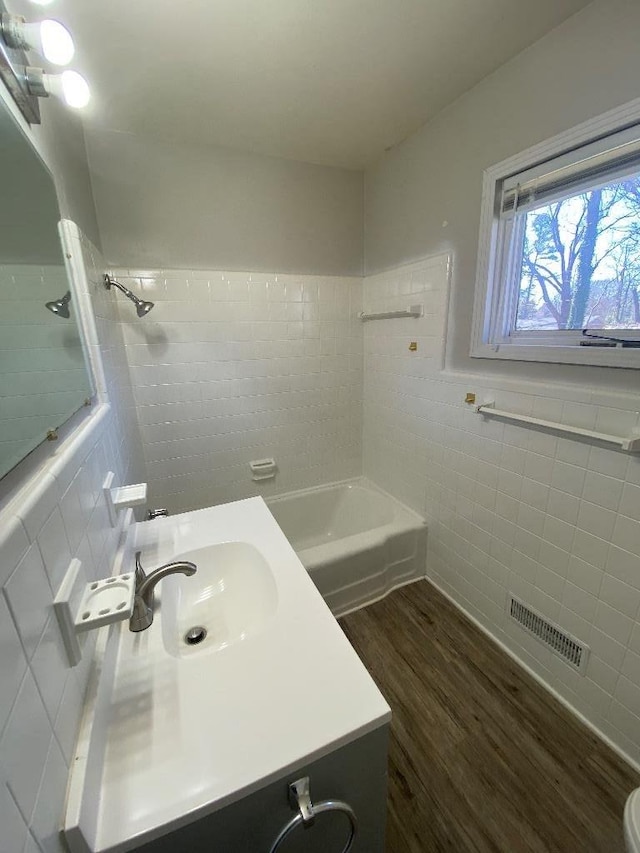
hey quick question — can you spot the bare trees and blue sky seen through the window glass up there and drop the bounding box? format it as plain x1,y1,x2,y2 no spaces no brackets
515,177,640,331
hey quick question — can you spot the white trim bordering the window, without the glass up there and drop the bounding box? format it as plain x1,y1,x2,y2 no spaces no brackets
470,98,640,368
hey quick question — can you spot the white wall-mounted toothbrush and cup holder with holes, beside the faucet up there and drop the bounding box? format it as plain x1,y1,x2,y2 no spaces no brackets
53,559,136,666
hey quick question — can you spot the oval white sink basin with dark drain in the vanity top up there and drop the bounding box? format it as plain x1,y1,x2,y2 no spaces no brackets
161,542,278,657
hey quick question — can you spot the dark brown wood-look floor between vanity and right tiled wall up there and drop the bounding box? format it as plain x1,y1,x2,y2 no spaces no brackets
340,581,640,853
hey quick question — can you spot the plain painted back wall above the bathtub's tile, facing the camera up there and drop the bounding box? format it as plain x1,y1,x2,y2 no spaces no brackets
87,132,363,275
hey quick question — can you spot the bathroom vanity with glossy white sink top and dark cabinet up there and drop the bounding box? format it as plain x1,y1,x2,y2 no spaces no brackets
64,498,391,853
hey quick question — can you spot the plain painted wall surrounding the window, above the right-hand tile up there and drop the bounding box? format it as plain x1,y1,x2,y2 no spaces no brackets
365,0,640,391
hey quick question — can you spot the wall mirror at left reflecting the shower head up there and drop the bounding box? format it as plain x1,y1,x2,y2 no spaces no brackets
0,96,93,477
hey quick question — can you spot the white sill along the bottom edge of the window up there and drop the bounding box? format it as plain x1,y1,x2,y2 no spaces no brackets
470,344,640,369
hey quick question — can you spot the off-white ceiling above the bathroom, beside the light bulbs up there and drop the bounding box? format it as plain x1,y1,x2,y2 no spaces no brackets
57,0,588,168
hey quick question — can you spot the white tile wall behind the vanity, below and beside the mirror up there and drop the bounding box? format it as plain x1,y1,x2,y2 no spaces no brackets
0,226,140,853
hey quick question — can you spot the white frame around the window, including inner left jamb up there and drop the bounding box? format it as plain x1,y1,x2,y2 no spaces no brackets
470,98,640,369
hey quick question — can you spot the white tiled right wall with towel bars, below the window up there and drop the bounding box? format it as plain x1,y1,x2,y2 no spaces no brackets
364,256,640,762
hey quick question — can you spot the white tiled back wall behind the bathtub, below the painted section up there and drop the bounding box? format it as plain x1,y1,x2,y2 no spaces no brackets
114,270,362,512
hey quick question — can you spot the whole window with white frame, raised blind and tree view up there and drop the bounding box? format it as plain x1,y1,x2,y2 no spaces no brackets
471,104,640,367
